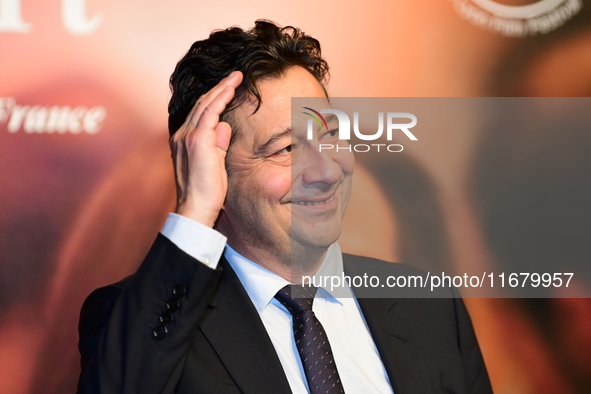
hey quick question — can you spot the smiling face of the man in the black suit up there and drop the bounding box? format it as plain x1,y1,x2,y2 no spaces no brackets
220,67,354,267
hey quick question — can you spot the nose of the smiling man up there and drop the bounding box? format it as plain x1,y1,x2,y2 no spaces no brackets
300,148,343,184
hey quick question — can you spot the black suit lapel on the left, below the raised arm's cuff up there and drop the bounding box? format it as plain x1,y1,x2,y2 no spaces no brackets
200,257,291,394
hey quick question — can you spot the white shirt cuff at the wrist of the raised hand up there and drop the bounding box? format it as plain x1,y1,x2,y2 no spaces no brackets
161,213,227,269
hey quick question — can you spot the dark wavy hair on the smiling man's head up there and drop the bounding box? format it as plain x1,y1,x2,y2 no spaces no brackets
168,20,328,137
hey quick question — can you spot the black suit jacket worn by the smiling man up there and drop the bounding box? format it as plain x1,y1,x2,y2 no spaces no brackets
78,235,492,394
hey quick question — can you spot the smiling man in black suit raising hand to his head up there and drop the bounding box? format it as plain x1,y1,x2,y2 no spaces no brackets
78,21,491,394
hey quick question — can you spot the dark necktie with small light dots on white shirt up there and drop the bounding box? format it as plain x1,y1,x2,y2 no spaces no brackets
275,285,345,394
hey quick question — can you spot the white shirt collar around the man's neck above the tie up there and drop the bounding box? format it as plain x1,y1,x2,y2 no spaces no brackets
224,242,343,313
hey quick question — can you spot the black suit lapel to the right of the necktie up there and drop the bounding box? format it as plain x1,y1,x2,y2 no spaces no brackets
343,255,432,394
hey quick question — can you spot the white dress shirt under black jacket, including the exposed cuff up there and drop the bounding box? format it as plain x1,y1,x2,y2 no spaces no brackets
162,214,393,394
